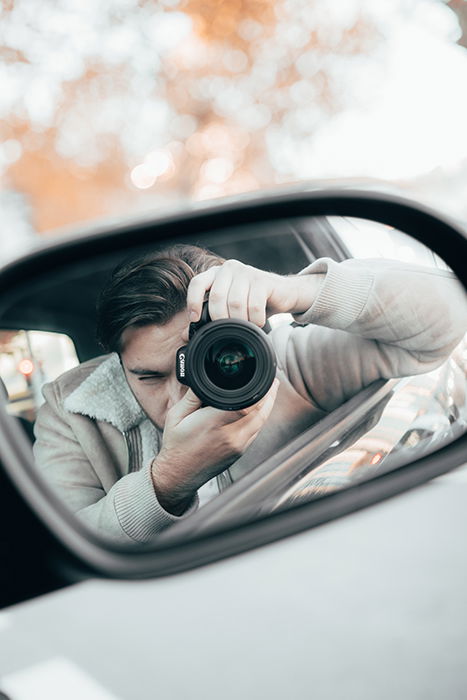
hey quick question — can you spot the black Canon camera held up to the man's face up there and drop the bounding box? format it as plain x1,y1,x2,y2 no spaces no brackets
176,302,277,411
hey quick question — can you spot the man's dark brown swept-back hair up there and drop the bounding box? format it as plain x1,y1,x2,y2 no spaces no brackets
97,244,224,353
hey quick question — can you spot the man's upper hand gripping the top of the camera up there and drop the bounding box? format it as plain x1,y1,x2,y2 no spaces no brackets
187,260,323,328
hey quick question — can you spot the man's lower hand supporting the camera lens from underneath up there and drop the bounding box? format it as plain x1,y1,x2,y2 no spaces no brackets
151,379,279,515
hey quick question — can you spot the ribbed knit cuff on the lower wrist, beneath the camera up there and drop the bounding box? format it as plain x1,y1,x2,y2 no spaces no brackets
114,465,198,543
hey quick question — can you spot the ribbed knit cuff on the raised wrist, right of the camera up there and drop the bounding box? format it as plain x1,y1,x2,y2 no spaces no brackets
294,258,373,330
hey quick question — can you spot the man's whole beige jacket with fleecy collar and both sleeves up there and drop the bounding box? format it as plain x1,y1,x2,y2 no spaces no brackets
34,258,467,543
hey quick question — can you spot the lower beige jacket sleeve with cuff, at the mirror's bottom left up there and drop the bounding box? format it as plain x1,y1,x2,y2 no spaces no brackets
33,383,197,544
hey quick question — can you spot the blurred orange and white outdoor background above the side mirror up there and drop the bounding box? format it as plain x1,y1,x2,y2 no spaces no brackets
0,0,467,262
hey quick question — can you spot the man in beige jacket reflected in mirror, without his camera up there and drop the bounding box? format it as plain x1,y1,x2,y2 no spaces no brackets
34,246,467,543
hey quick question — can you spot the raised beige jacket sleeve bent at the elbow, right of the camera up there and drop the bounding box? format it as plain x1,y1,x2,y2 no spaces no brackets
272,258,467,411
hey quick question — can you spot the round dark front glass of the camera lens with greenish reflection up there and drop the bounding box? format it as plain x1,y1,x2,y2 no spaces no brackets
204,338,256,389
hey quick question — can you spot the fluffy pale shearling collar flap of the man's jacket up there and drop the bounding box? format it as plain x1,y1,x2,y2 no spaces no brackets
64,353,146,433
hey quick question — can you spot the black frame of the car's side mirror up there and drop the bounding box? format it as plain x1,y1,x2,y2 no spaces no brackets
0,189,467,583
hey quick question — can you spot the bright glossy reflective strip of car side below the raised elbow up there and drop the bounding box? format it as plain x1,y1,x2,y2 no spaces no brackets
274,352,467,508
